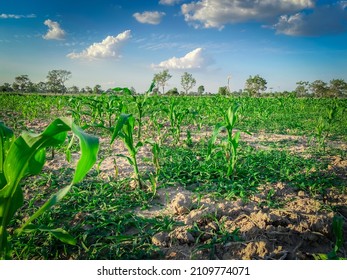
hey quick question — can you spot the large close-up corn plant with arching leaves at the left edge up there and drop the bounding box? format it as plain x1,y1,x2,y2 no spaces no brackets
0,118,99,259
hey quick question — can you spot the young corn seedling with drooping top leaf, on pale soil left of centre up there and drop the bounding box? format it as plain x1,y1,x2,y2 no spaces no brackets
111,114,143,187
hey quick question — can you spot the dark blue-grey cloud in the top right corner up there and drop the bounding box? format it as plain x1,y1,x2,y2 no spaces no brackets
273,1,347,36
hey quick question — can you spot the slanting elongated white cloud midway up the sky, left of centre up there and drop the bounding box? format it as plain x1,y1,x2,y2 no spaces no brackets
67,30,131,60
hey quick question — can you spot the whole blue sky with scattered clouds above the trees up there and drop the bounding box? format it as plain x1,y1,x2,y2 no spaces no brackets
0,0,347,92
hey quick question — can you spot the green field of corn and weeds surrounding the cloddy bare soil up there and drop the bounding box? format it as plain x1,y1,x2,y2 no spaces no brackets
0,91,347,259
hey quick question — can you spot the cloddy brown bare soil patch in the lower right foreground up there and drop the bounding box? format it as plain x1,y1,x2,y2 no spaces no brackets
137,183,347,260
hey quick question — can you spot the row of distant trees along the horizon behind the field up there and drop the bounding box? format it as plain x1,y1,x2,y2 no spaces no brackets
0,69,347,97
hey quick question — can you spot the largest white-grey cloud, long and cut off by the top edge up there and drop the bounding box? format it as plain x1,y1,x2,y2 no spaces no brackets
181,0,314,29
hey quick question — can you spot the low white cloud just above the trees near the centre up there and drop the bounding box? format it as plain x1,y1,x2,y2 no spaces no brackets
152,48,207,69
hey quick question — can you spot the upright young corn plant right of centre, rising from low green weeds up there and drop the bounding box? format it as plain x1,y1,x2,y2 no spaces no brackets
207,103,240,178
